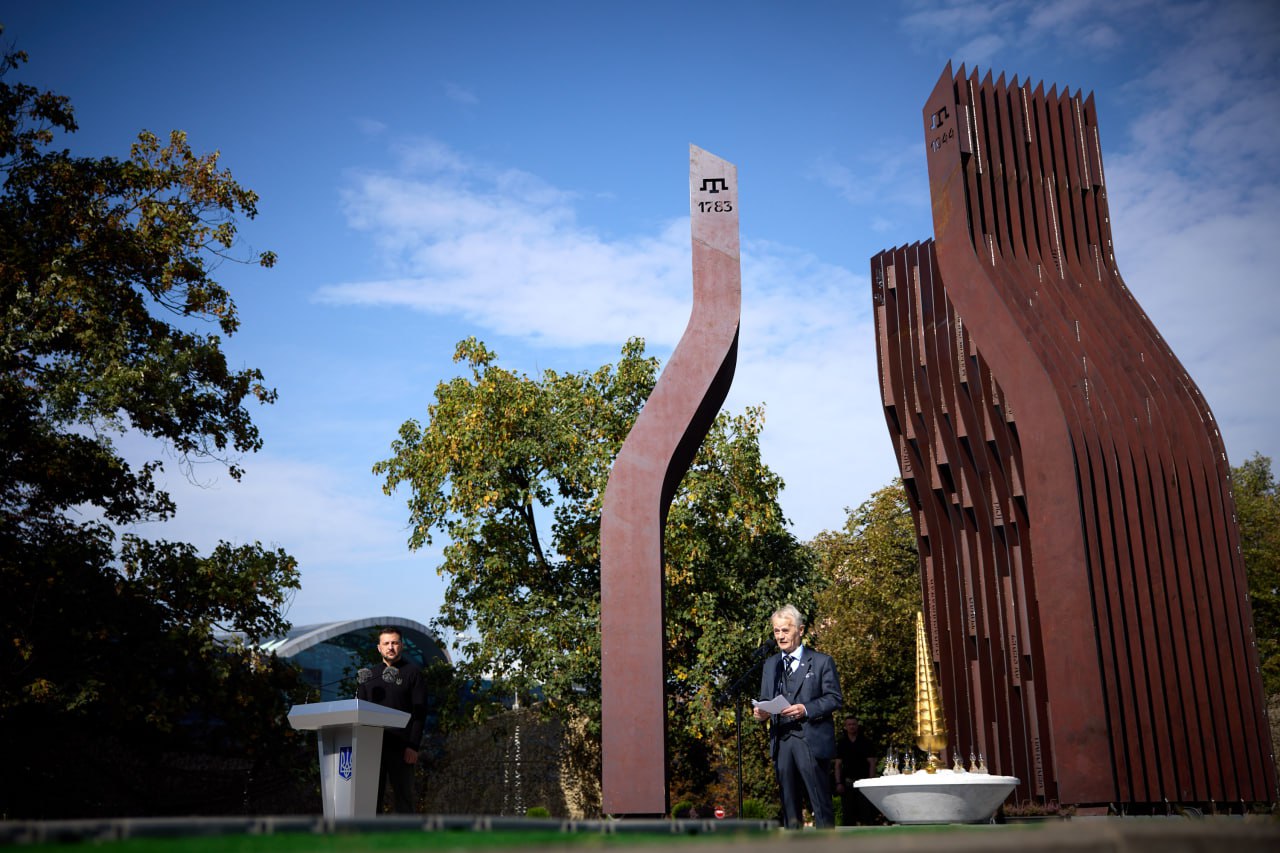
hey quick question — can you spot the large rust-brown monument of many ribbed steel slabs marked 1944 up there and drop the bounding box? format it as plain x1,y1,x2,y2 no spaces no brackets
872,65,1276,806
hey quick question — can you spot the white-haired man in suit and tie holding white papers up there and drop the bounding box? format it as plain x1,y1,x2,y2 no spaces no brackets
753,605,845,829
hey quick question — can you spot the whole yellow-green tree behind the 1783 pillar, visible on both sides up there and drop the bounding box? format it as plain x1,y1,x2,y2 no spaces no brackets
374,338,812,790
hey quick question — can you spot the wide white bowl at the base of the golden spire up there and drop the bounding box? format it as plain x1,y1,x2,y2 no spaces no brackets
854,770,1018,824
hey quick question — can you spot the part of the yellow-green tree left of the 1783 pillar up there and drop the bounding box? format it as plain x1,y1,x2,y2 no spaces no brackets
374,338,645,707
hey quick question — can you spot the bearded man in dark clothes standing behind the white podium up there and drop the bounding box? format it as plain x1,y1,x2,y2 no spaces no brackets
356,628,426,813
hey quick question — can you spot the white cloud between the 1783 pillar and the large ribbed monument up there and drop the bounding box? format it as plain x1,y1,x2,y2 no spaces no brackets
726,241,897,538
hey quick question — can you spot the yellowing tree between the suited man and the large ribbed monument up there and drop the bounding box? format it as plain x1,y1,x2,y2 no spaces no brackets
810,480,920,745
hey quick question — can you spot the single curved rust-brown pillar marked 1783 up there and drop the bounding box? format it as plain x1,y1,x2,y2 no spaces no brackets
600,146,742,816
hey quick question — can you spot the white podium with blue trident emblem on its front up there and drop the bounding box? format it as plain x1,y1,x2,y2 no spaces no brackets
289,699,410,820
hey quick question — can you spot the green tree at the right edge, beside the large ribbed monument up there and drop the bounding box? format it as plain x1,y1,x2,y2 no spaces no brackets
1231,453,1280,697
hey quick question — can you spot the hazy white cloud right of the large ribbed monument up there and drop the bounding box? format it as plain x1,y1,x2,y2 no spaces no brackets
1102,5,1280,464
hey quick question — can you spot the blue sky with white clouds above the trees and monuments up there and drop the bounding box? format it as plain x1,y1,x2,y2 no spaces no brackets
0,0,1280,637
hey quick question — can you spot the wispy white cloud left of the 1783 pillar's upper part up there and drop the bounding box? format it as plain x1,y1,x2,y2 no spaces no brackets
319,142,690,346
